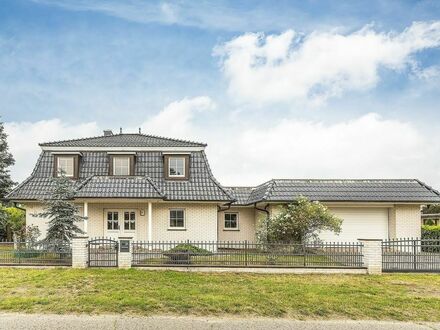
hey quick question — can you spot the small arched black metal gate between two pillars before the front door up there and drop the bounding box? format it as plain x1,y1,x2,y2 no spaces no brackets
88,238,119,267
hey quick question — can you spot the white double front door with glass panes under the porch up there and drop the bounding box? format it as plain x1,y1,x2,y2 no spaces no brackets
104,209,137,239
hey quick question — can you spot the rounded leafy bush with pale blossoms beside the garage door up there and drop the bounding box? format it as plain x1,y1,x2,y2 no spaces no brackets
257,197,342,243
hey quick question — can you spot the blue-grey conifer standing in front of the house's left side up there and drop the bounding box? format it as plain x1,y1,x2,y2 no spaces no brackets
35,175,85,246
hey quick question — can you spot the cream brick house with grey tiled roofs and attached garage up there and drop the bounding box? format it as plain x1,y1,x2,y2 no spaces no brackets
8,131,440,241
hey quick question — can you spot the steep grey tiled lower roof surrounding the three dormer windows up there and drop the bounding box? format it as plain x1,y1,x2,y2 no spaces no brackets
7,151,233,202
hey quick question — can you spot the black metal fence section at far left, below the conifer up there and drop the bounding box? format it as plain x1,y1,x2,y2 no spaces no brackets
0,242,72,266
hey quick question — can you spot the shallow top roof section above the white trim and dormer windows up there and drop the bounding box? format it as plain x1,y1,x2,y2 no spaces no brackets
40,134,206,147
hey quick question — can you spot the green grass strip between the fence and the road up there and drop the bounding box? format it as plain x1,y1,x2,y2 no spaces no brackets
0,268,440,321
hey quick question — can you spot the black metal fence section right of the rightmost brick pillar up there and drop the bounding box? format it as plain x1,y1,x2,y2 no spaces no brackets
382,238,440,272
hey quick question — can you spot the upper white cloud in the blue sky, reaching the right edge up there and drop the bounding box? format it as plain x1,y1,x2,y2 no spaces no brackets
214,21,440,104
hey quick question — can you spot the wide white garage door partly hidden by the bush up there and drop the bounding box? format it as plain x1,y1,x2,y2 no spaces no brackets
319,207,388,242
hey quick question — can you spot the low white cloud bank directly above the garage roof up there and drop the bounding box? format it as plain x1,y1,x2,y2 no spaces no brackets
208,113,440,191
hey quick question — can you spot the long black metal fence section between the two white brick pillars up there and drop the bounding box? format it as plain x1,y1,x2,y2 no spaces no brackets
132,241,363,268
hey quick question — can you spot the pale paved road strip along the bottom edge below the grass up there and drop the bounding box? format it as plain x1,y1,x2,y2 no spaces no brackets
0,314,440,330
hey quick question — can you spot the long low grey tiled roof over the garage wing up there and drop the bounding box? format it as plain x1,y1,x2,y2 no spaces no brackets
228,179,440,205
